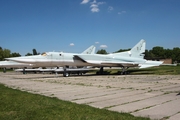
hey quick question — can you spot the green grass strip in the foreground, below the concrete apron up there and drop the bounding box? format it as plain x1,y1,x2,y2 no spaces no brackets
0,84,149,120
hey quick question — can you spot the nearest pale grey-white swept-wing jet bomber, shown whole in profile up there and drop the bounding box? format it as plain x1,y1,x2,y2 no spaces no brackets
6,40,162,77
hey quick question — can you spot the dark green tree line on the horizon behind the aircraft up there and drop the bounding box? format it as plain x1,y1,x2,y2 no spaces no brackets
0,46,180,63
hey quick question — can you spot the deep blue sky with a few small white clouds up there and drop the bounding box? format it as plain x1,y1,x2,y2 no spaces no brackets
0,0,180,55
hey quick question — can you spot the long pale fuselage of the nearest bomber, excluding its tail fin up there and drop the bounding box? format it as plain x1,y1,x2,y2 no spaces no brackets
7,52,145,67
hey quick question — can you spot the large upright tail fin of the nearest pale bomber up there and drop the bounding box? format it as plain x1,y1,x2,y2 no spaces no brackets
129,39,146,58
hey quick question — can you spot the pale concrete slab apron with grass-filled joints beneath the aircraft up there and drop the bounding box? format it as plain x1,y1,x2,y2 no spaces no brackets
0,73,180,120
